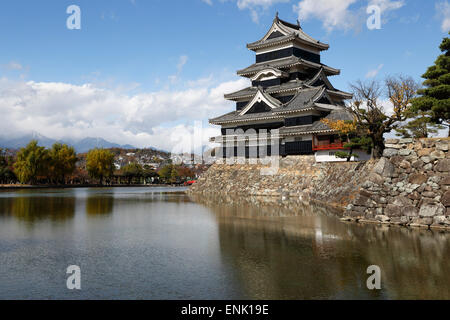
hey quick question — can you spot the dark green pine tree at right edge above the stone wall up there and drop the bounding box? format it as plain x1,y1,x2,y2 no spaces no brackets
412,32,450,136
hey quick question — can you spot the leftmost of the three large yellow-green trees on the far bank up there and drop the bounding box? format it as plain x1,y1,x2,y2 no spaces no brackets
14,140,50,184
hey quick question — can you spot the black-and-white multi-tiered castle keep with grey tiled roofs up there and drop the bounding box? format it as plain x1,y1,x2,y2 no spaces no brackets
210,14,368,161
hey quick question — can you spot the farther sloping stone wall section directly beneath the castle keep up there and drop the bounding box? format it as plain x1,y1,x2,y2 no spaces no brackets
189,156,375,208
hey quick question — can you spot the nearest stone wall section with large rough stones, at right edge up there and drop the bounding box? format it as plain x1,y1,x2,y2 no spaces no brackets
346,138,450,229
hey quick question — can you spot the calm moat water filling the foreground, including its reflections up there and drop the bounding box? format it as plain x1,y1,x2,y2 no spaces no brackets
0,188,450,299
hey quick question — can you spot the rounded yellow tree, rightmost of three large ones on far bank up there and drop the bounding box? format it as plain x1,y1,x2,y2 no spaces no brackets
86,149,114,184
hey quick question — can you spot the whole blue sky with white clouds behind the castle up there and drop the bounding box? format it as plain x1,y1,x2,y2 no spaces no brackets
0,0,450,150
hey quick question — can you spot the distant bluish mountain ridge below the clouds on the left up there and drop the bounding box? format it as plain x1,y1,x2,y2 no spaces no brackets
0,132,137,153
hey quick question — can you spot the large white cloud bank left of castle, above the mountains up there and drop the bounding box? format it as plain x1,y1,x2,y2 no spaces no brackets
0,78,248,153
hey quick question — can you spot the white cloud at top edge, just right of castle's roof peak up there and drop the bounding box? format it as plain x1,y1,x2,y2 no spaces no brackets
294,0,404,32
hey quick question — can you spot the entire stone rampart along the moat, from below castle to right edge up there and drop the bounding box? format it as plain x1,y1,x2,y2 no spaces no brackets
189,138,450,229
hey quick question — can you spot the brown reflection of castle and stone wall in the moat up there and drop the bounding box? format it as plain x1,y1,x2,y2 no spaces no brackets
194,197,450,299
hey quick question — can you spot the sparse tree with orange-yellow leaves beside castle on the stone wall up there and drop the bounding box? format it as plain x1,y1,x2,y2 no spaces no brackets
348,76,418,158
